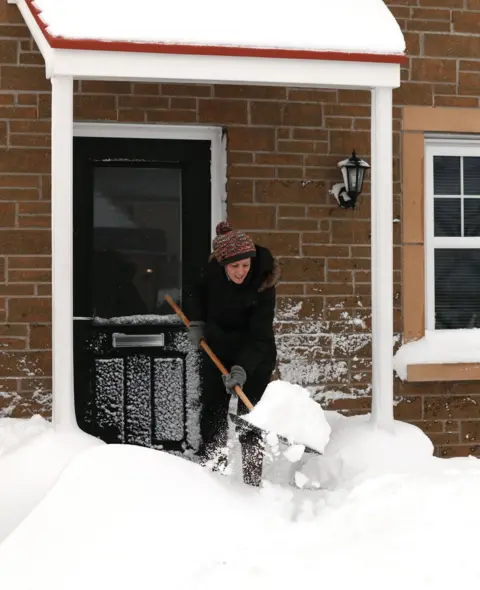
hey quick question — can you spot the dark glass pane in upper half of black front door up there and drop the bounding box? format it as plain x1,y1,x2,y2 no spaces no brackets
93,165,182,318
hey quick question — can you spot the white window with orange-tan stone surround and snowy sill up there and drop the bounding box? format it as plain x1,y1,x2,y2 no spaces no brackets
397,107,480,381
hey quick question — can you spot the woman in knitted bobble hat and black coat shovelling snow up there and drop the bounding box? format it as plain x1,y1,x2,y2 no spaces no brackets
189,222,279,486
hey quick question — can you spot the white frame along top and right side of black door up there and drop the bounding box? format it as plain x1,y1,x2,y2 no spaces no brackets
73,122,227,240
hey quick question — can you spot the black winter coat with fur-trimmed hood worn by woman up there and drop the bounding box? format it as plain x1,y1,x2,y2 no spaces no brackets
186,246,280,375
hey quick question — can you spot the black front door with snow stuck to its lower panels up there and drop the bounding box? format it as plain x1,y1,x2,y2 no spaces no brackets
73,137,211,451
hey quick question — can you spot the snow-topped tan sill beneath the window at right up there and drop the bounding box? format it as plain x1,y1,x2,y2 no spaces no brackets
393,329,480,381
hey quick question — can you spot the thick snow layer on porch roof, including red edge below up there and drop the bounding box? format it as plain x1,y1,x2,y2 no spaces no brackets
26,0,405,63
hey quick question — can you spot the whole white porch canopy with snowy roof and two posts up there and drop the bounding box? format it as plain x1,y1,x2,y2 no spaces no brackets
8,0,406,430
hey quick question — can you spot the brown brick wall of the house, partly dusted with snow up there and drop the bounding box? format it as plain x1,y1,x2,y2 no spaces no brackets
0,0,480,456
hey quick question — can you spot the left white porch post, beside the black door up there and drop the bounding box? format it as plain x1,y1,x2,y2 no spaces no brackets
52,76,77,431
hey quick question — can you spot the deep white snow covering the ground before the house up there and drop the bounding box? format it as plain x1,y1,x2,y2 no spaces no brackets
0,400,480,590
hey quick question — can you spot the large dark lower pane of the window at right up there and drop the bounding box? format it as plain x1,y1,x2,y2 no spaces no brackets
435,248,480,330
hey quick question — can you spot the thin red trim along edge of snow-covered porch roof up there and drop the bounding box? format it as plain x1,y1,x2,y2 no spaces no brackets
25,0,407,64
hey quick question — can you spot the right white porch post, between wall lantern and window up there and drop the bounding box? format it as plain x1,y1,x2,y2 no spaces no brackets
371,88,393,428
